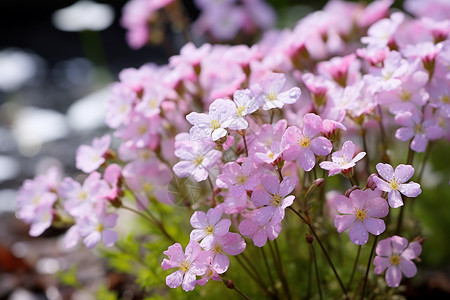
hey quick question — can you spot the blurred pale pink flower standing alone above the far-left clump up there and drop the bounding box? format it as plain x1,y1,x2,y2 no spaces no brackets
76,134,111,173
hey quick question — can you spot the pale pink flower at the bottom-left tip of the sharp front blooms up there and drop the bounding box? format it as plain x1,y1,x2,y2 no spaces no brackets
161,241,210,292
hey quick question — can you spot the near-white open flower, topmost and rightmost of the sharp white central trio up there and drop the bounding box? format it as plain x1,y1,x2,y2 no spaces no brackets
251,73,301,110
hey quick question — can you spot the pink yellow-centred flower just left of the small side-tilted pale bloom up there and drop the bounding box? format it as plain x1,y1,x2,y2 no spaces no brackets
281,113,333,172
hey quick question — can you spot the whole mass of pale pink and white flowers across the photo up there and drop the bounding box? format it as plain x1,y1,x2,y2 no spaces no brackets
14,0,450,294
